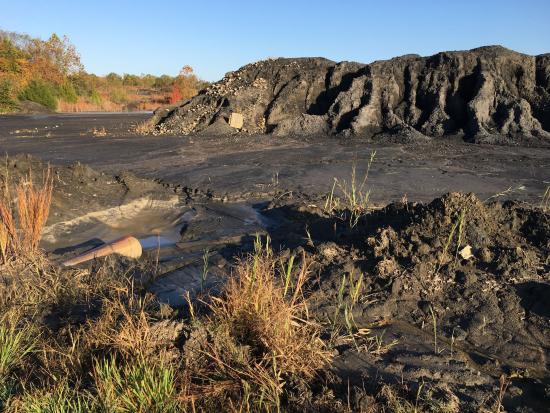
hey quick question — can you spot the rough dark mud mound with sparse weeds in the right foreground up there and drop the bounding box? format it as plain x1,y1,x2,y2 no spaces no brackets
267,193,550,412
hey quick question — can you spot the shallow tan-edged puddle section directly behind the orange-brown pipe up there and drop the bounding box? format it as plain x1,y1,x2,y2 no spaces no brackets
42,197,268,253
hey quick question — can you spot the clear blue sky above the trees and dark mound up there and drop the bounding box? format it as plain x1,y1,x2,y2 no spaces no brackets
0,0,550,80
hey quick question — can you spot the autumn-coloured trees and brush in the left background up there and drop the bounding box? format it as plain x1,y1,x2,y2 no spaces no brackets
0,30,207,112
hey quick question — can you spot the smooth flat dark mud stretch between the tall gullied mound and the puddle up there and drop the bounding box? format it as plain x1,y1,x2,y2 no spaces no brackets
0,114,550,205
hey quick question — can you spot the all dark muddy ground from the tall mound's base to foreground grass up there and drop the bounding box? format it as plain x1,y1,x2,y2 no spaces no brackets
0,114,550,412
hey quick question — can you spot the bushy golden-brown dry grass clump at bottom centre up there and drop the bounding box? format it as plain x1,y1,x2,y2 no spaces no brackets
183,238,331,411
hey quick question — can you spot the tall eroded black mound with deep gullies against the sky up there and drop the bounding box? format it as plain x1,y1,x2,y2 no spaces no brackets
153,46,550,143
